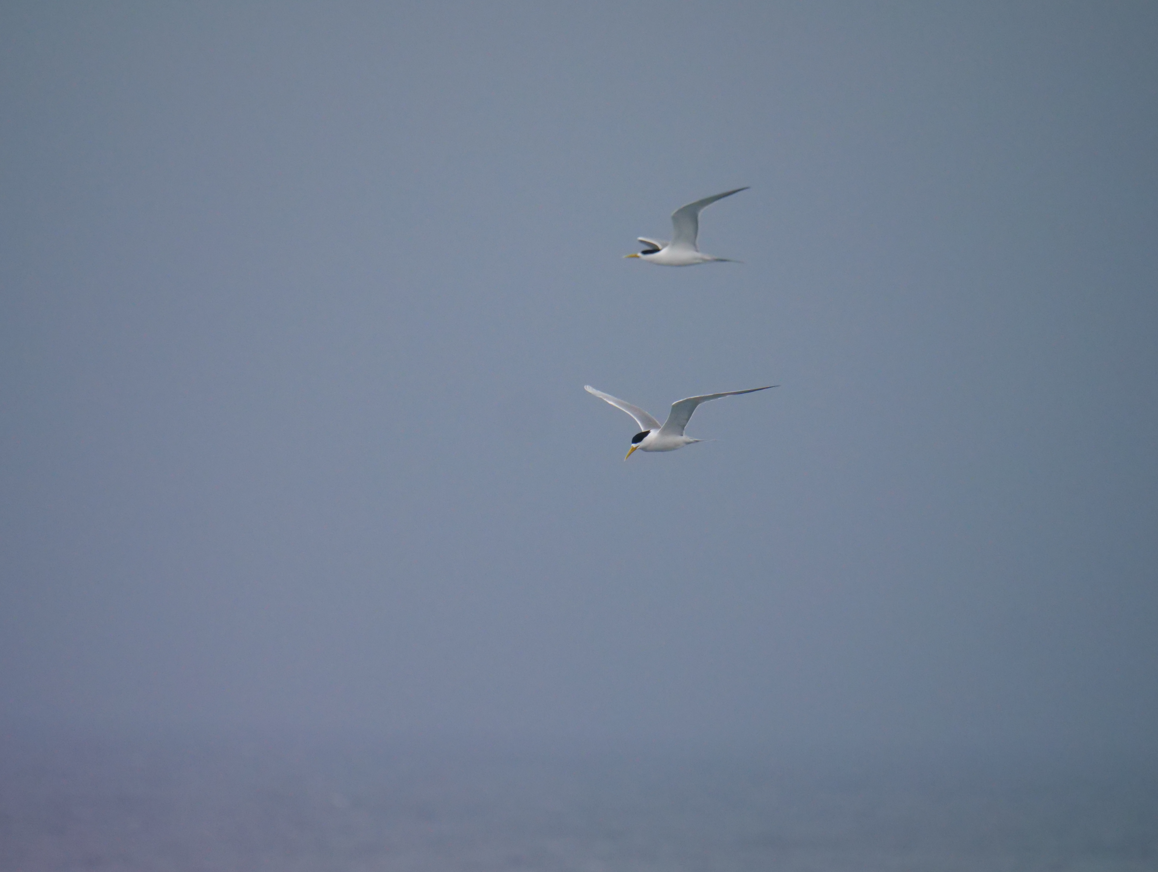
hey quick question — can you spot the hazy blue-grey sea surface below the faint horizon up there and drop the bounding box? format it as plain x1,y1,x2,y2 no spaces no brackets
0,734,1158,872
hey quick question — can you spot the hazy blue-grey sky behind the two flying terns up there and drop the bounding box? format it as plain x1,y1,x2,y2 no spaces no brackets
0,2,1158,753
